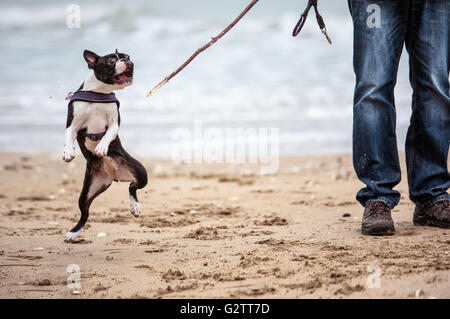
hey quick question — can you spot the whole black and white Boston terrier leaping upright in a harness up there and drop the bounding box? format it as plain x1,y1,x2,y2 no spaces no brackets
63,50,147,242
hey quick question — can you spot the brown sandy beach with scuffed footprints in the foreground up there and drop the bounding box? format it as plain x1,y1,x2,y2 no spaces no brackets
0,153,450,298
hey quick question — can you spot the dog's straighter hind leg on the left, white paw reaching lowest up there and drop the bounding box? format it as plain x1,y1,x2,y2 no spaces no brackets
64,164,112,242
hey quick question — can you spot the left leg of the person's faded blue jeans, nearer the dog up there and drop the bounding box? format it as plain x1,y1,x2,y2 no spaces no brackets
349,0,409,208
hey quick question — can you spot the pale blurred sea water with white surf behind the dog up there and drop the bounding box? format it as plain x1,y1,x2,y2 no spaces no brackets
0,0,411,158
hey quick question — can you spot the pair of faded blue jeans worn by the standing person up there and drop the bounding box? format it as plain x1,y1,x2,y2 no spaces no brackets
348,0,450,208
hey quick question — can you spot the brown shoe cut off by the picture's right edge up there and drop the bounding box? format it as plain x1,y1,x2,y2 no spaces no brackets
413,200,450,228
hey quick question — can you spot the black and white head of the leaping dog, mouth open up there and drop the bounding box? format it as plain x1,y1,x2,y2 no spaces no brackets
83,49,134,88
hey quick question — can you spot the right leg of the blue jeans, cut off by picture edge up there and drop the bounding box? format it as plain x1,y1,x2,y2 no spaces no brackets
406,0,450,209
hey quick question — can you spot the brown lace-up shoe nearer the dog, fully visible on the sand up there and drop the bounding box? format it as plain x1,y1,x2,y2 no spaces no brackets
361,201,395,235
